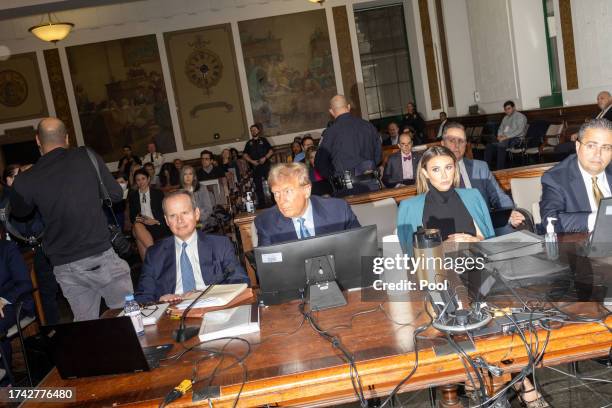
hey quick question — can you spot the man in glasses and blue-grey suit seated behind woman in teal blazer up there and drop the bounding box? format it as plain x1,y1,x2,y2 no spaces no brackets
442,122,525,235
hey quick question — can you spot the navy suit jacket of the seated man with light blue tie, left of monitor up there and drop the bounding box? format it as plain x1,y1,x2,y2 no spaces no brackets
135,232,249,303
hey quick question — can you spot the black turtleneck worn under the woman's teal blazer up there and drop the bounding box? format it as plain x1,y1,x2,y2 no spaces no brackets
423,183,476,240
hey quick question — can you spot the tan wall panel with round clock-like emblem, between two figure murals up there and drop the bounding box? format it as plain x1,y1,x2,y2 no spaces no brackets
164,24,248,149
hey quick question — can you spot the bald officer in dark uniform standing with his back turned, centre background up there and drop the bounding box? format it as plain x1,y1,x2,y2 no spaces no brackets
315,95,381,192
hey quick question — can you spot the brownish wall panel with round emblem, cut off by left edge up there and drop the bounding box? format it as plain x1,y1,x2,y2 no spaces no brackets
0,52,48,123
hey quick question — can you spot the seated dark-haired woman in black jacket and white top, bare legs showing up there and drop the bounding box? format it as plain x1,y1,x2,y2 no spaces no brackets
128,169,170,259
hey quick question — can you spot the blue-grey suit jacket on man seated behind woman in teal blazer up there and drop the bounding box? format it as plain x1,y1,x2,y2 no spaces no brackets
460,157,512,211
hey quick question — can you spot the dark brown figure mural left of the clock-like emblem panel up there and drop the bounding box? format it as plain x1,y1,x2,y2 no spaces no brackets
66,35,176,162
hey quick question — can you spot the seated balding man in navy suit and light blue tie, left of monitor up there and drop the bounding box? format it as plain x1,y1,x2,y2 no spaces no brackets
135,190,248,303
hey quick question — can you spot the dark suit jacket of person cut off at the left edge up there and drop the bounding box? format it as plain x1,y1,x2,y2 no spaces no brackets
0,241,34,314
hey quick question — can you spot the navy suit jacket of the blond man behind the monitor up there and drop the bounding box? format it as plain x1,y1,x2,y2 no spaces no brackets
255,195,361,246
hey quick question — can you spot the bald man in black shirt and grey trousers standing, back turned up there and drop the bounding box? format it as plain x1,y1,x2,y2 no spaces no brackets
11,118,133,321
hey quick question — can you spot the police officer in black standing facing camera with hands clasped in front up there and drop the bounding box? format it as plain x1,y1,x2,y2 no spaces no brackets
242,123,274,207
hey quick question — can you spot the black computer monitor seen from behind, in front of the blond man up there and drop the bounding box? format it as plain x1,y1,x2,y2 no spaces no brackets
254,225,378,305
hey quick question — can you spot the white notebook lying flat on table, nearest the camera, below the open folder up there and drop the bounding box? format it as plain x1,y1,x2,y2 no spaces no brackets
199,304,259,341
